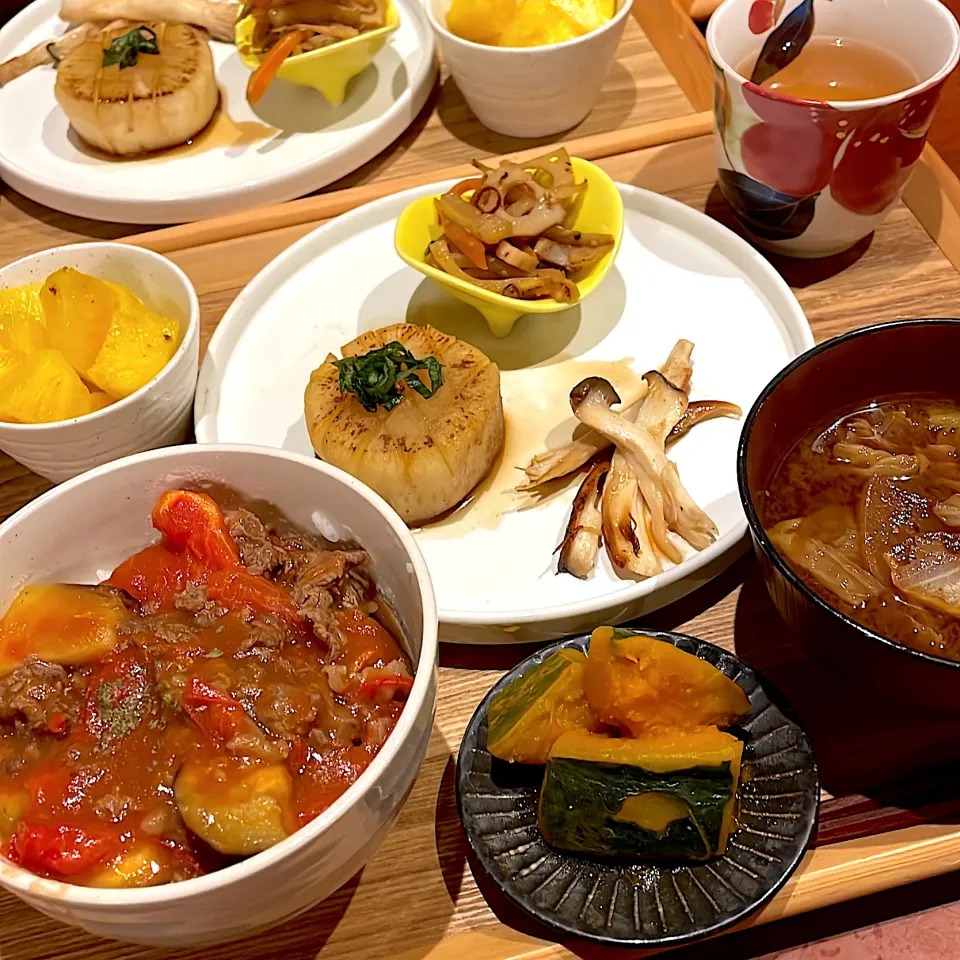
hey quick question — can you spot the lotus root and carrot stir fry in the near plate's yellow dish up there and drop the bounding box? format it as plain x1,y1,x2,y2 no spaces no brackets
426,149,616,303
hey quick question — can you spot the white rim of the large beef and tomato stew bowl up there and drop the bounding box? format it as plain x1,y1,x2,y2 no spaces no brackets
0,443,439,910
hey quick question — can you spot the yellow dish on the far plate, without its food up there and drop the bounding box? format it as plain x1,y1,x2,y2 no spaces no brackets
235,0,400,106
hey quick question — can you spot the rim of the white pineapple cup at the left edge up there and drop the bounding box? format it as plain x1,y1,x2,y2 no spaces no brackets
0,240,200,434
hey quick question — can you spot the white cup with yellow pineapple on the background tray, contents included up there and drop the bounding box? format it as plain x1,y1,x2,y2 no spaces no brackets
426,0,632,138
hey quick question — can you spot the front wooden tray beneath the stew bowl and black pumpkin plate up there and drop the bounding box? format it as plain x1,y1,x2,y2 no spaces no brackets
0,125,960,960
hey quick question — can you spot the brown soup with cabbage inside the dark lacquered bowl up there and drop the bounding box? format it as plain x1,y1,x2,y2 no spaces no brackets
760,399,960,660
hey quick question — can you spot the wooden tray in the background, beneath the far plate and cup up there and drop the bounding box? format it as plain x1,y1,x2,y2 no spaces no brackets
0,0,696,255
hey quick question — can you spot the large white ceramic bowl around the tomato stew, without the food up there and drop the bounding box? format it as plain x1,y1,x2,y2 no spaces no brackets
0,444,437,947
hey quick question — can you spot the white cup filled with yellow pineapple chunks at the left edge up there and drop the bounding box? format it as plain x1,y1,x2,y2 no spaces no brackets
0,243,200,482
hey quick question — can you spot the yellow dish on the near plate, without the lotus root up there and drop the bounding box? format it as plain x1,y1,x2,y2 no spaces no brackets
393,157,623,337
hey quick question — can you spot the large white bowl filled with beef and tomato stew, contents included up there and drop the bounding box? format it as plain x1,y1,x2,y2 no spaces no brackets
0,445,437,946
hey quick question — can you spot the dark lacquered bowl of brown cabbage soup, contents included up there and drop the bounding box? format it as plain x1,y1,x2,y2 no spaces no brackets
738,319,960,716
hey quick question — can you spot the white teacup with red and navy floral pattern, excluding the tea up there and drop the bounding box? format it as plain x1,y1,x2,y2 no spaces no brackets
707,0,960,257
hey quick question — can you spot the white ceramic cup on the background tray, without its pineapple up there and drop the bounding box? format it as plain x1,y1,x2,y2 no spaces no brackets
425,0,633,137
